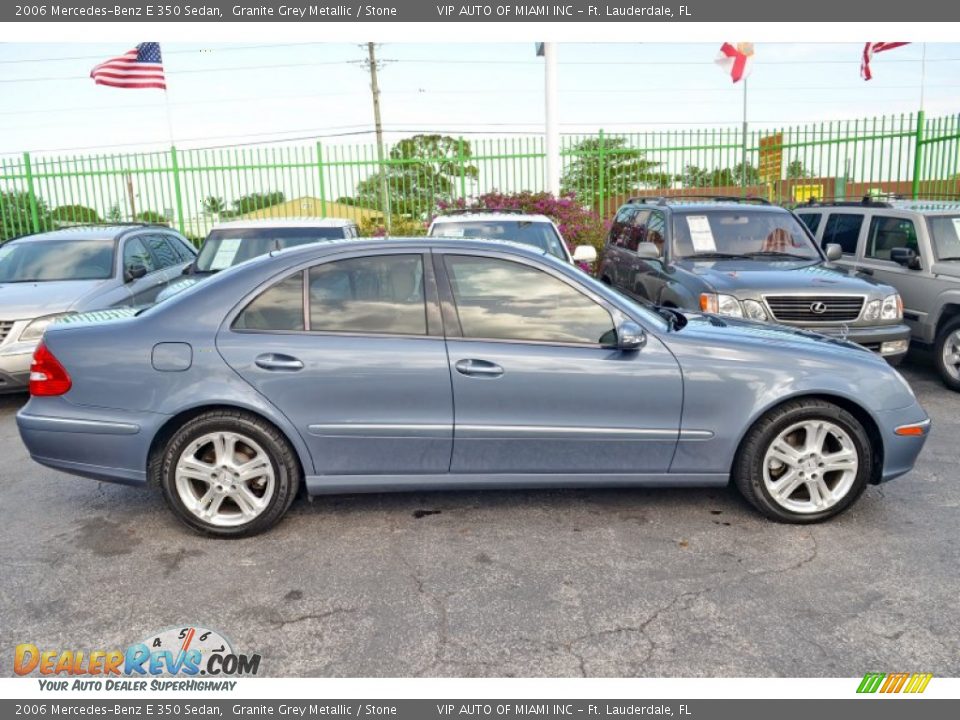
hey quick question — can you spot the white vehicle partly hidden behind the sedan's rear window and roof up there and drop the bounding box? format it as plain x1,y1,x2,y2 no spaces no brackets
157,217,360,302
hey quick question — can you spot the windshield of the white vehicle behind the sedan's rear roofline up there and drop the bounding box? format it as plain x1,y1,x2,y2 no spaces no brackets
195,227,345,272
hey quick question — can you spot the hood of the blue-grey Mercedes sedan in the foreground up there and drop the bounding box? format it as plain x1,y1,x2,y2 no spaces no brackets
677,313,886,365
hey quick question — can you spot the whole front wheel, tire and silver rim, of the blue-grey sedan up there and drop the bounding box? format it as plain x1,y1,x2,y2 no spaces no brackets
733,399,874,523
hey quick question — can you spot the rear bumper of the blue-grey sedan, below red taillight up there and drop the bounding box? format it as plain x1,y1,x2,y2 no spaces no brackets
17,398,166,485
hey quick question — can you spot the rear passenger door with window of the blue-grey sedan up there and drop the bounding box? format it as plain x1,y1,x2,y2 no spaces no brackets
217,249,453,475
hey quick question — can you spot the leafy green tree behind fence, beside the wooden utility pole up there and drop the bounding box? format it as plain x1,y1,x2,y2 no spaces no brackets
353,135,480,215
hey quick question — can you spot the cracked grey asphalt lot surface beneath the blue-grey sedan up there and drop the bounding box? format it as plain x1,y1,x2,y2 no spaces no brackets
0,357,960,677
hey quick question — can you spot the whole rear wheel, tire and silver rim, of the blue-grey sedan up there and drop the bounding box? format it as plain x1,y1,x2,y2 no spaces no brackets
160,411,300,537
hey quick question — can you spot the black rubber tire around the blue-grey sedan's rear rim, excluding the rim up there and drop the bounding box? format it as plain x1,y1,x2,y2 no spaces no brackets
156,410,302,538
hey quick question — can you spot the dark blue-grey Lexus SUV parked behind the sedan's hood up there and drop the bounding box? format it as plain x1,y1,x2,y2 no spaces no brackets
598,197,910,365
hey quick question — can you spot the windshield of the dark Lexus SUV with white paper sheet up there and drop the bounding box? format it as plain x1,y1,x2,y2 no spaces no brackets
673,209,820,260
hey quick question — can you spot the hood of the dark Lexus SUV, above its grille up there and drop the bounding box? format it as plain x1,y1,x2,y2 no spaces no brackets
677,259,893,294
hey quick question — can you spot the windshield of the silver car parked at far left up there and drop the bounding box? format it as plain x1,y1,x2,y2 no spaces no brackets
0,238,116,282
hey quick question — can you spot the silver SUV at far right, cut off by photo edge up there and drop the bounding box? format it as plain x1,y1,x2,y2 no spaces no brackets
796,198,960,392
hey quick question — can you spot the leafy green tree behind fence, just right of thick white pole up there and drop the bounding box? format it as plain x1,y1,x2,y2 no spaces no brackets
560,136,672,206
